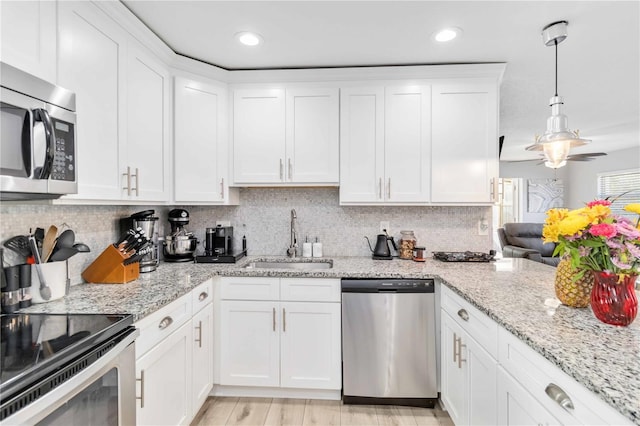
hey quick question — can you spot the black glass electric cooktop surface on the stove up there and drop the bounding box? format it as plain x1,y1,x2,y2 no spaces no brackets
0,313,133,399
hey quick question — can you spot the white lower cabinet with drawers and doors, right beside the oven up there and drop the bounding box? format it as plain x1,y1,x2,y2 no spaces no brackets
136,280,213,425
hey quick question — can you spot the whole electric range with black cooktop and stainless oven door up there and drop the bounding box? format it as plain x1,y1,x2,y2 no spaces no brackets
0,313,139,425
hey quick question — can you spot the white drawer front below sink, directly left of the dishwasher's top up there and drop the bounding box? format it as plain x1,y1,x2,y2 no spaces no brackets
280,278,340,302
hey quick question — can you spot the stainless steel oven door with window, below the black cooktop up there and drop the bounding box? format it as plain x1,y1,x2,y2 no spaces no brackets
2,330,140,426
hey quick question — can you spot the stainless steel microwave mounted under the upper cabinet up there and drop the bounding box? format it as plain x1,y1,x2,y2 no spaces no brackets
0,62,78,200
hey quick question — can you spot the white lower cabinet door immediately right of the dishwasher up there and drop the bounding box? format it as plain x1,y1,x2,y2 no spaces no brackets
440,311,469,425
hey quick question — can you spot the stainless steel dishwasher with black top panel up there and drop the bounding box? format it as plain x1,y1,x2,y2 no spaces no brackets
342,279,438,407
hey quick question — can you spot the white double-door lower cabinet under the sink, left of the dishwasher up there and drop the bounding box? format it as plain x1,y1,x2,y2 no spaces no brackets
220,278,342,390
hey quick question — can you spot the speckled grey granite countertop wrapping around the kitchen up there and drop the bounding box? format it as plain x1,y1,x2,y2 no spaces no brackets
18,257,640,424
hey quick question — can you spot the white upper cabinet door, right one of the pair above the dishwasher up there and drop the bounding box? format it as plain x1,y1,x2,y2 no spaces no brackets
384,86,431,202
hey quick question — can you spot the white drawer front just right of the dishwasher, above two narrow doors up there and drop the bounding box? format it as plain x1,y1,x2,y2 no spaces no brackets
440,285,498,358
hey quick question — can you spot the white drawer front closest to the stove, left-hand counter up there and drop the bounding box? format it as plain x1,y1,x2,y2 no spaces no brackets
135,294,191,358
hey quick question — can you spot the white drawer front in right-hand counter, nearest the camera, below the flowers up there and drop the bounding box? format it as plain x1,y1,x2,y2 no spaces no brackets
498,327,631,425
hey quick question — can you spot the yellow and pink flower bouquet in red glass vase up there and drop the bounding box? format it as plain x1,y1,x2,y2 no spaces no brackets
542,200,640,325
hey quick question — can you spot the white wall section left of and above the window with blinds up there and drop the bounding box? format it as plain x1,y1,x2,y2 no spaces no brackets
567,146,640,209
